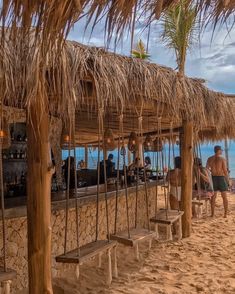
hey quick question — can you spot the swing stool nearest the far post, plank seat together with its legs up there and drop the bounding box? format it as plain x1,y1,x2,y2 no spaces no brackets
150,210,184,241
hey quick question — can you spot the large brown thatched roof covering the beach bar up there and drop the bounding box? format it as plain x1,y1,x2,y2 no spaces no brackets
1,37,235,142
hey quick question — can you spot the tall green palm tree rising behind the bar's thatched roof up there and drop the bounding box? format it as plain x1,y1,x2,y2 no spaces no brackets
161,0,199,75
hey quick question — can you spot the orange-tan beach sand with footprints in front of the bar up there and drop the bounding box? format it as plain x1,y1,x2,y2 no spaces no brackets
53,195,235,294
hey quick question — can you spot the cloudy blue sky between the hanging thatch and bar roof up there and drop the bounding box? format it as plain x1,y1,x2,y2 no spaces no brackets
69,16,235,94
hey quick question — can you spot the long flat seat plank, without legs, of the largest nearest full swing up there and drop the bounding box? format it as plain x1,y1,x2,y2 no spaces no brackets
56,240,117,264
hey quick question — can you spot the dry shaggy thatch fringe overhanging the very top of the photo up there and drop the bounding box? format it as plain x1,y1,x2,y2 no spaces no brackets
0,0,235,50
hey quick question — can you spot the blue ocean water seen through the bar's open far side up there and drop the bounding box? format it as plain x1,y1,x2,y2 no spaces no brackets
62,141,235,178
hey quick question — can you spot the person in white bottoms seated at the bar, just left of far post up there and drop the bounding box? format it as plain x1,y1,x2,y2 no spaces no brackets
166,156,181,210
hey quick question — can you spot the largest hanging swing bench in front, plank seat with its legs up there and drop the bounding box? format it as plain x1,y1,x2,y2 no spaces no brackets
56,240,118,285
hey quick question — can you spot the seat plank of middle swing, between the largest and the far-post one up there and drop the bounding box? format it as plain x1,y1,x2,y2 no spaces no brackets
110,229,156,247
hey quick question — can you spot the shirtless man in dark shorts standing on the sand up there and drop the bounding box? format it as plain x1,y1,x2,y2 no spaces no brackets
206,146,229,217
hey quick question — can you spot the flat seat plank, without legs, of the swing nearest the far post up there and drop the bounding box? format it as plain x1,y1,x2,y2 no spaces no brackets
150,210,184,225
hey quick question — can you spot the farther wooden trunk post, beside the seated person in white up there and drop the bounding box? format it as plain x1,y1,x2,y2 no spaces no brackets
181,121,193,238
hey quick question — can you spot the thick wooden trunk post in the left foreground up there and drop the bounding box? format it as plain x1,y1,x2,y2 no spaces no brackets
27,99,53,294
